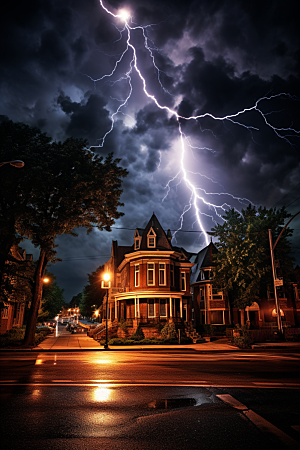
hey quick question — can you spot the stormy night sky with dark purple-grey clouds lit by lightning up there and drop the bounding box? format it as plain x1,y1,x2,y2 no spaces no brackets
0,0,300,301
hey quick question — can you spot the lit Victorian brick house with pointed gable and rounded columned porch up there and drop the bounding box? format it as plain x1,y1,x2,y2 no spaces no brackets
103,213,193,337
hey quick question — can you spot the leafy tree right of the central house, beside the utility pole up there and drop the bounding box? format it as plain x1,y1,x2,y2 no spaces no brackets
209,205,293,309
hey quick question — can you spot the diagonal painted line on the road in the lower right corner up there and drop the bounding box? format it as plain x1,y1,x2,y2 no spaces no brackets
217,394,299,450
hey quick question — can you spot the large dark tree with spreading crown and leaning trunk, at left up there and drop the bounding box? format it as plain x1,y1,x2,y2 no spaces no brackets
0,121,127,346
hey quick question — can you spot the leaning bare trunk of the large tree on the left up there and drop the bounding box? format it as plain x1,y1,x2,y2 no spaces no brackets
23,249,48,347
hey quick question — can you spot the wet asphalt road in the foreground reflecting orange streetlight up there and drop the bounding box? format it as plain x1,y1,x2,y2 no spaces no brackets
0,350,300,450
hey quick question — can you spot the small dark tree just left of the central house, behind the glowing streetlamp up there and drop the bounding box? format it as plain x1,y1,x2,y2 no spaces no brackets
79,266,106,317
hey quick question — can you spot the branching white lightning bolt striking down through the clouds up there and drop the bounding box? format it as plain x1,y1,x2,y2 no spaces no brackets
83,0,300,245
